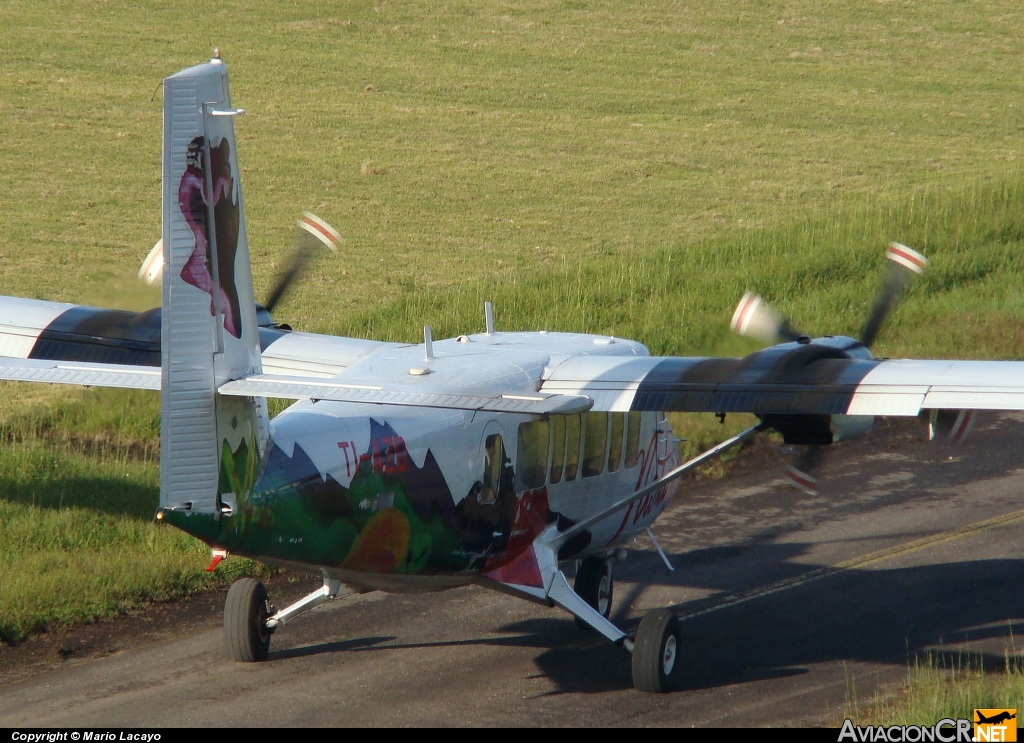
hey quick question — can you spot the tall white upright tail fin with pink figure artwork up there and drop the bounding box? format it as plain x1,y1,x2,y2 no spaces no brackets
160,58,269,517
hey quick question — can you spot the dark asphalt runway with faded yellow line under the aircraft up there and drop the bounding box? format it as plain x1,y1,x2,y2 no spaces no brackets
0,413,1024,727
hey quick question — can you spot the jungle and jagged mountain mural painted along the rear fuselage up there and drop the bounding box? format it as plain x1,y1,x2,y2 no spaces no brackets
165,419,577,574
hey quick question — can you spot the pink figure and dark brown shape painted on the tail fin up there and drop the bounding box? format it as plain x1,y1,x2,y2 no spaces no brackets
178,137,242,338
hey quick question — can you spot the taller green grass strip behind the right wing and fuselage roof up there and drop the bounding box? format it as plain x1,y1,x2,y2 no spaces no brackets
331,176,1024,358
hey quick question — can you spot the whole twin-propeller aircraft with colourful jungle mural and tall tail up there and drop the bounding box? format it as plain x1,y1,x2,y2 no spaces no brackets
0,58,1024,692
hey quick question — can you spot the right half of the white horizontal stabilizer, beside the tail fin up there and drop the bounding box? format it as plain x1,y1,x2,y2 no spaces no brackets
217,375,592,416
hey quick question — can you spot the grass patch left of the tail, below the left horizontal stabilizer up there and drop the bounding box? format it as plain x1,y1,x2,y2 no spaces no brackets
0,388,268,642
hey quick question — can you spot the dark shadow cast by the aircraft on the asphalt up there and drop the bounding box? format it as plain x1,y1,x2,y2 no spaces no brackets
270,543,1024,694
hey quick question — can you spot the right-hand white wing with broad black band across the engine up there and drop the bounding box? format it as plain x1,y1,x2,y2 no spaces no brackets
540,344,1024,416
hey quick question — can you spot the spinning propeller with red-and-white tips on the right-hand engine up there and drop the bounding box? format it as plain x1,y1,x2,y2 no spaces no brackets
729,243,928,495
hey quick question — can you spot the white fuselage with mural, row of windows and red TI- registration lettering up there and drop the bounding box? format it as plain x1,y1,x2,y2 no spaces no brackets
161,333,679,591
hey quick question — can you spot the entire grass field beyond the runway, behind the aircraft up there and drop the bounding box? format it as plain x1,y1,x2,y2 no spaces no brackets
0,0,1024,640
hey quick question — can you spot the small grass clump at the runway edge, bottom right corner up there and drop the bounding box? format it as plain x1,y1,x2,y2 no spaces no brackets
846,654,1024,727
